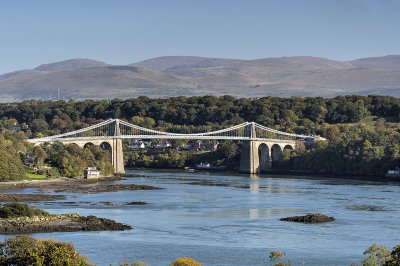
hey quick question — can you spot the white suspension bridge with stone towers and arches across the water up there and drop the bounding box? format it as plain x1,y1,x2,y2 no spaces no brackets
28,119,316,173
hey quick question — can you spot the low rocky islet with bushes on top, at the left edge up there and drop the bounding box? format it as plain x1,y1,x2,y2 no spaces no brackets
0,203,132,234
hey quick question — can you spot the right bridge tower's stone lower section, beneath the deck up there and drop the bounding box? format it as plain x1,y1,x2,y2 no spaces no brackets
239,141,260,174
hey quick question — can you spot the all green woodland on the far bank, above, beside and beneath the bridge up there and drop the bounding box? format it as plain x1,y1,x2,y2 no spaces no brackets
0,95,400,180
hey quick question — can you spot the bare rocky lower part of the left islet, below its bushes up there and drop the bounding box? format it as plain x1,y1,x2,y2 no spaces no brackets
0,214,132,234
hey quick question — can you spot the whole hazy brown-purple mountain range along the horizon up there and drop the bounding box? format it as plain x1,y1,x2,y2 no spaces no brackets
0,55,400,102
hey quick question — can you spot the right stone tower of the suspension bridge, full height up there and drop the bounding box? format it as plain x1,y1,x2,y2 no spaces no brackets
239,122,260,174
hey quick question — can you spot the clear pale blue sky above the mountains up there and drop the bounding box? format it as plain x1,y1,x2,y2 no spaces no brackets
0,0,400,73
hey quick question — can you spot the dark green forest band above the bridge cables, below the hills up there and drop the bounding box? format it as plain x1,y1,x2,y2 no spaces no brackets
0,95,400,136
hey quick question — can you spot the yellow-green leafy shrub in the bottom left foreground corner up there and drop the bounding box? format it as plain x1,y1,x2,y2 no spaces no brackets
0,236,92,266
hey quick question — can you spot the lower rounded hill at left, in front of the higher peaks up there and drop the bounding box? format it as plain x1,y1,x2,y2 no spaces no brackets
0,66,197,99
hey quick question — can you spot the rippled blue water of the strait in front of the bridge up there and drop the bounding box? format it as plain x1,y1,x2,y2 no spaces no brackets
4,170,400,265
